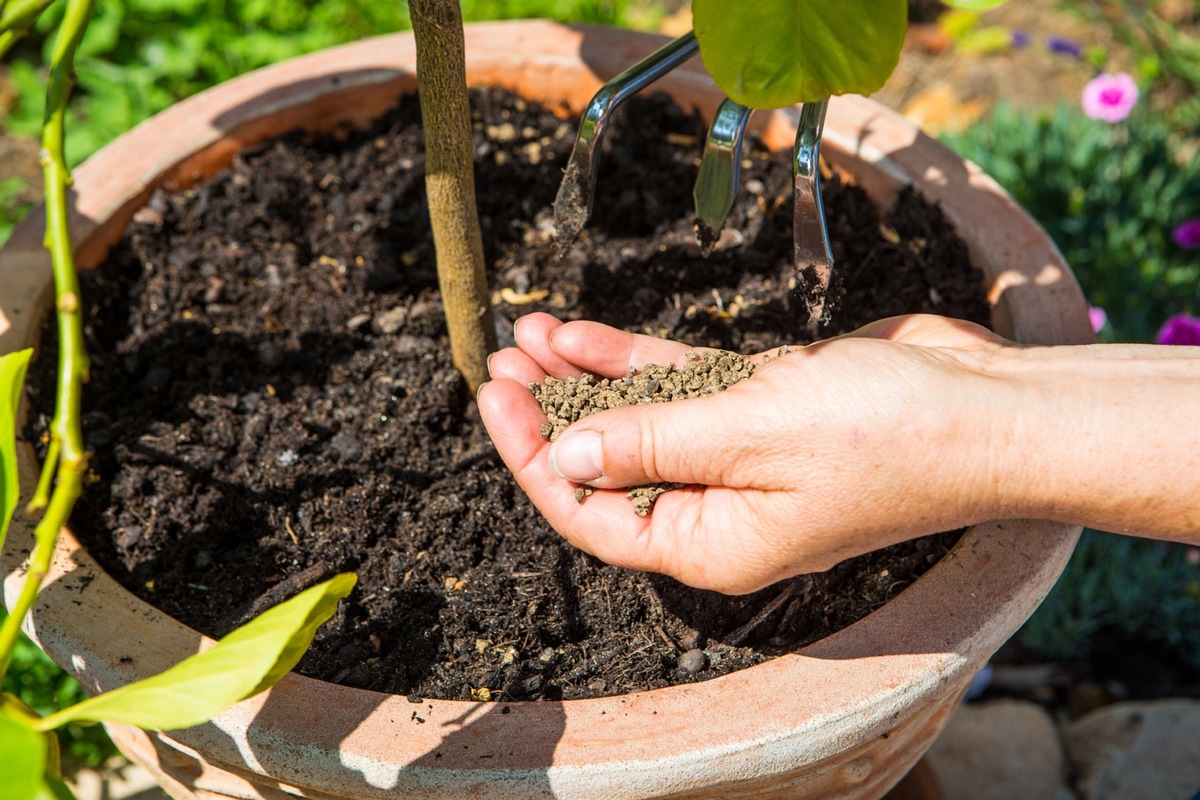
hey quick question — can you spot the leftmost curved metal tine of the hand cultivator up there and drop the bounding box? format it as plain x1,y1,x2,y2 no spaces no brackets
554,31,700,249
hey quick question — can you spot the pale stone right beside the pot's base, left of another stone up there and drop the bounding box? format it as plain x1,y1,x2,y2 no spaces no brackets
926,700,1075,800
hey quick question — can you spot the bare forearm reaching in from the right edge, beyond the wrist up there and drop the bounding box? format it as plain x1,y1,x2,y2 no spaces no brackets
979,344,1200,543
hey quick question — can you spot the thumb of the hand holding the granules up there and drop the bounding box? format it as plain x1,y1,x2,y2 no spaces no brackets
550,392,745,489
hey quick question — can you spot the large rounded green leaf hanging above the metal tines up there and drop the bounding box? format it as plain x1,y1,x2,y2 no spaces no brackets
692,0,908,108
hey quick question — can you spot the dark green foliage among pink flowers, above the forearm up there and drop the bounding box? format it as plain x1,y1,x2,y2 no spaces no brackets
946,106,1200,342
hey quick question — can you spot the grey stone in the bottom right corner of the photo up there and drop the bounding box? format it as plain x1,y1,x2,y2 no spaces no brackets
1063,699,1200,800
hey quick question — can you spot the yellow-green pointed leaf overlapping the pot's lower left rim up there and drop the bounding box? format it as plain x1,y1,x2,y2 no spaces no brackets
40,573,358,730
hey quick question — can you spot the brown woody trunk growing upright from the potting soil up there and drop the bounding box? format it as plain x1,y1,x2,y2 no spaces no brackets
408,0,497,392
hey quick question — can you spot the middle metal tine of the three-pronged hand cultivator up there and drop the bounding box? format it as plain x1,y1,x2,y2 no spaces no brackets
691,98,752,255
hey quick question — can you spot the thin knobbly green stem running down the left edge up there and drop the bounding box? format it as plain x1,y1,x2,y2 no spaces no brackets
0,0,92,676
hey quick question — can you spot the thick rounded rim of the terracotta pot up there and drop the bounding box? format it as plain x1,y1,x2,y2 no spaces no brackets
0,22,1091,796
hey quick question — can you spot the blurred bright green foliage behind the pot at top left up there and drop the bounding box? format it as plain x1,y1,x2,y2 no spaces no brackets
6,0,661,164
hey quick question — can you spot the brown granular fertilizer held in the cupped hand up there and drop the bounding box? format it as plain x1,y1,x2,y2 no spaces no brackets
529,350,756,517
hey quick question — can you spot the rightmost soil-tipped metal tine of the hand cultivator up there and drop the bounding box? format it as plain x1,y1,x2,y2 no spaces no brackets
792,97,833,332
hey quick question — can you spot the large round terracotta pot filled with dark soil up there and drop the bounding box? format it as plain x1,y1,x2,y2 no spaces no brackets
0,22,1091,800
